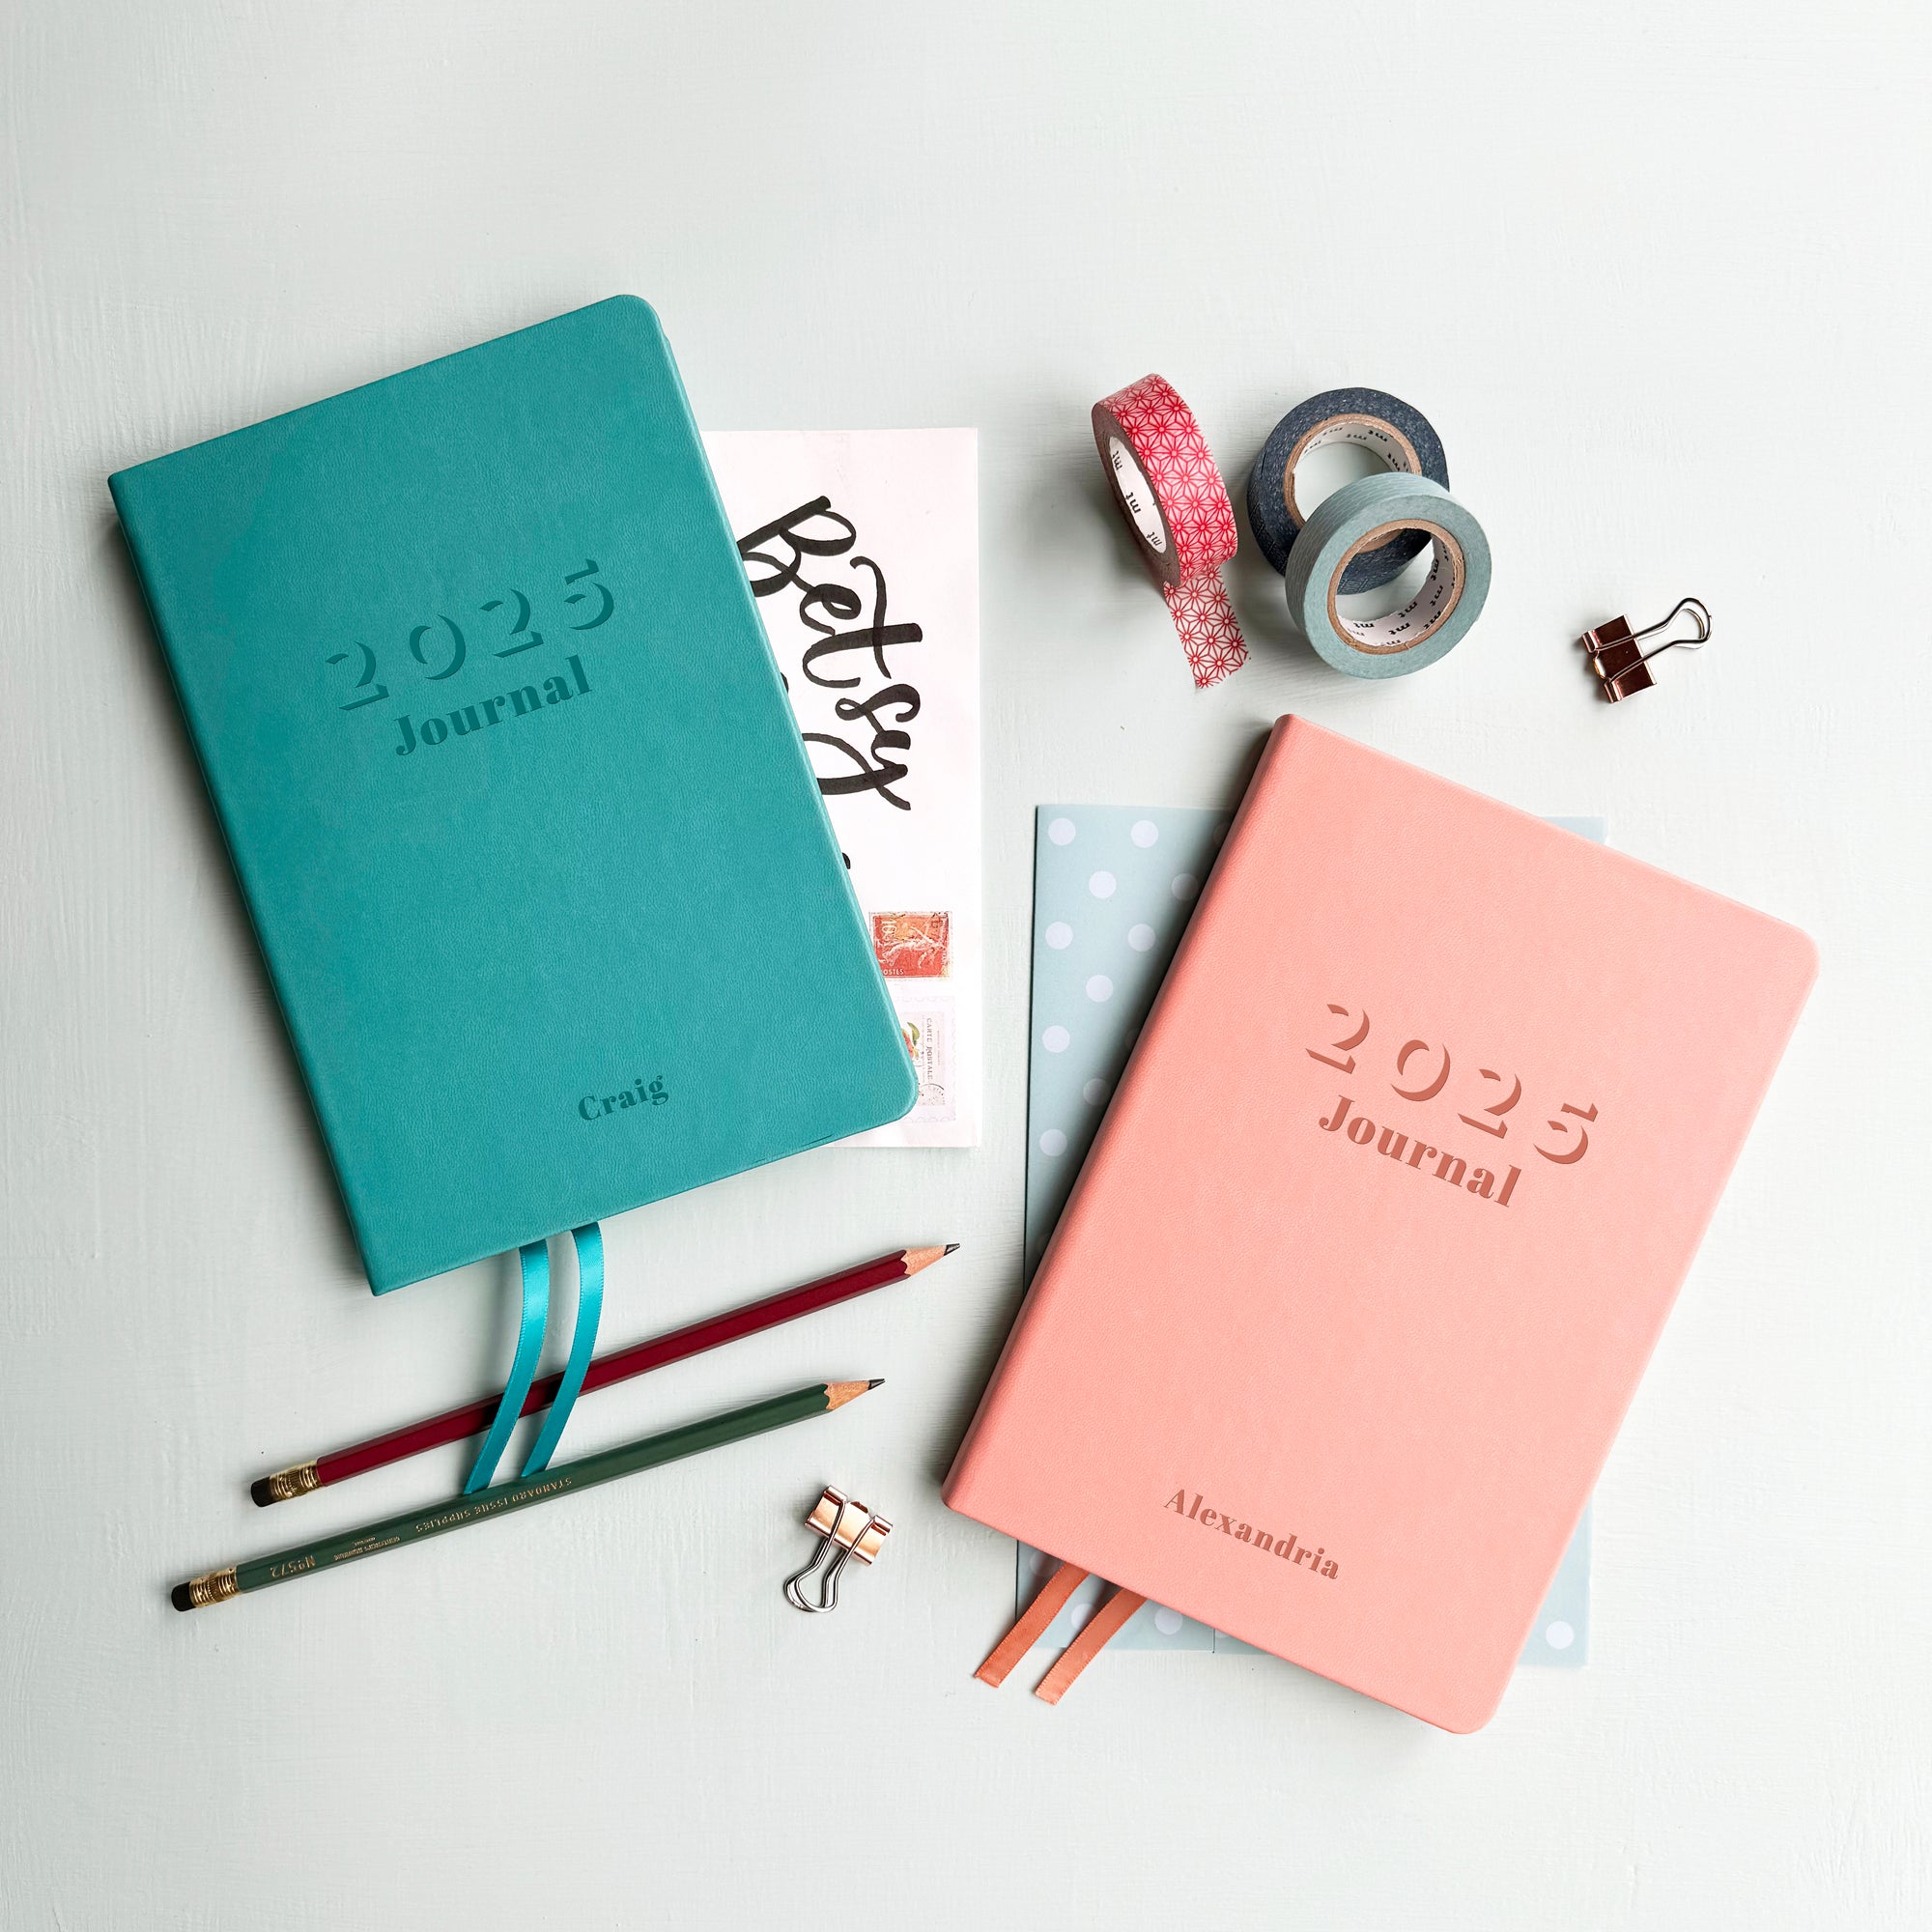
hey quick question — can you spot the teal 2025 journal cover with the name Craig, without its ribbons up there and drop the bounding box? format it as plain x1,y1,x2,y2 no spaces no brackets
110,296,918,1293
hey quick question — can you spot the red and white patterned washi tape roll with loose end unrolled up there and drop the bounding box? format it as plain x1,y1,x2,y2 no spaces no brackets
1094,375,1248,690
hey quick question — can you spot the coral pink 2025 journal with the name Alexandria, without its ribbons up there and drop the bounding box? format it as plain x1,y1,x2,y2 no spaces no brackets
945,717,1816,1731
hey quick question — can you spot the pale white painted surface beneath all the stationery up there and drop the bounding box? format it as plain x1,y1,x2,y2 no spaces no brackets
0,0,1932,1932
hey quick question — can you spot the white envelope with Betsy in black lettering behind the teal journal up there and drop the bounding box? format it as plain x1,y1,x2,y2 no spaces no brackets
705,429,981,1148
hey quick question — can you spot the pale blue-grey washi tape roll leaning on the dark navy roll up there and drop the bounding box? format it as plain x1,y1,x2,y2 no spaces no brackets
1285,473,1490,678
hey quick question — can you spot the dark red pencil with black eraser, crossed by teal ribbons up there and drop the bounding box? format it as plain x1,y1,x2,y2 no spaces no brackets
249,1240,958,1509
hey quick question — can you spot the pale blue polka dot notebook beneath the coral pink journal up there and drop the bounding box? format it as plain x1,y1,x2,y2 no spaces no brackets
1018,806,1605,1669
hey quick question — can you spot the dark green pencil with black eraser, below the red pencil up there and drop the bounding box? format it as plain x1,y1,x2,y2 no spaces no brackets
172,1381,879,1609
